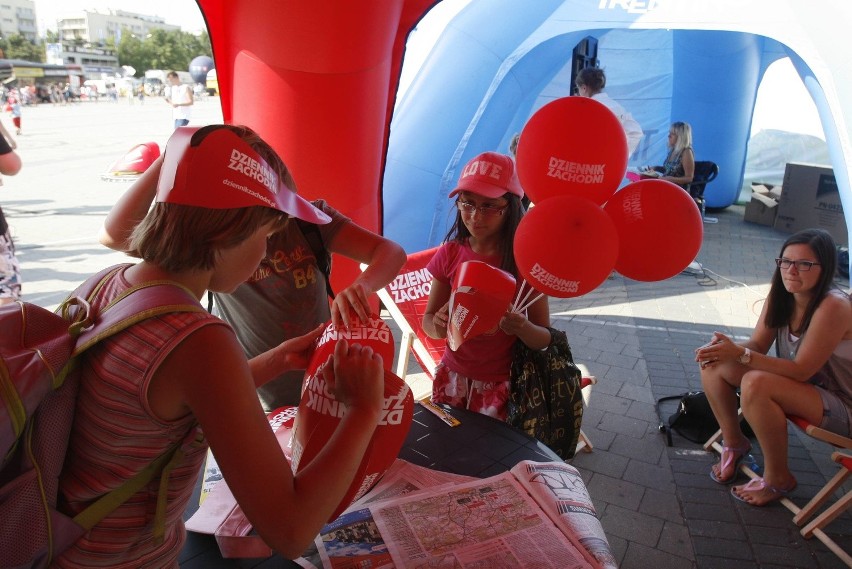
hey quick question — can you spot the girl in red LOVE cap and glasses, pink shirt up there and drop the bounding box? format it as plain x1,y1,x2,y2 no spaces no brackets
423,152,550,420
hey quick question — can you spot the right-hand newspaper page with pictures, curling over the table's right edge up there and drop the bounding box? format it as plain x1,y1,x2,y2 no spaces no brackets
511,460,618,569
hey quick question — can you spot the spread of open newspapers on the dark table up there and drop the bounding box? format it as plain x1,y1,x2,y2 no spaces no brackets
311,461,617,569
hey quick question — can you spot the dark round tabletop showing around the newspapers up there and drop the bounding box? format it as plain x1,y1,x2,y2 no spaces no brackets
180,405,562,569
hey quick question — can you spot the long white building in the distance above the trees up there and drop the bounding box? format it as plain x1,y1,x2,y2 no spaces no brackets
53,9,180,47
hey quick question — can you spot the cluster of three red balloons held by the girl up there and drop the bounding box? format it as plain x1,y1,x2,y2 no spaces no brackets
514,97,704,298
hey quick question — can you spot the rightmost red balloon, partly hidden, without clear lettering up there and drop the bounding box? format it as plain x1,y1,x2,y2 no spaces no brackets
604,180,704,281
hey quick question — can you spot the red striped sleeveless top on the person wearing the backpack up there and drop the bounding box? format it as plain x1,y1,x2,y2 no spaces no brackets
52,265,227,569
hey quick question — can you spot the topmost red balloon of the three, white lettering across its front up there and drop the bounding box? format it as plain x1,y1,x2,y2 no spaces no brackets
517,97,628,205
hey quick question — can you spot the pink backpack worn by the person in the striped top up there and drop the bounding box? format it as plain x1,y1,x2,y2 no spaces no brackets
0,265,204,568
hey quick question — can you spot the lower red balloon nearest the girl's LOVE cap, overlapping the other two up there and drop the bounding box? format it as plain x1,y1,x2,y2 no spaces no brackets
515,195,618,298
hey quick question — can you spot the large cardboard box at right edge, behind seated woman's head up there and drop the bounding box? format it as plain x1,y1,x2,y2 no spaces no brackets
775,163,849,245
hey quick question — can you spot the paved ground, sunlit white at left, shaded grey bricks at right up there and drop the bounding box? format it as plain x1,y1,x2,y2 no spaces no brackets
6,99,852,569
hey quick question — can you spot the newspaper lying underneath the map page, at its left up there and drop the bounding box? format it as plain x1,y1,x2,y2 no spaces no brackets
312,459,474,569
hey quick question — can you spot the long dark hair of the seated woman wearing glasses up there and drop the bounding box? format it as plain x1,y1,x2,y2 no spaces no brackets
766,229,837,335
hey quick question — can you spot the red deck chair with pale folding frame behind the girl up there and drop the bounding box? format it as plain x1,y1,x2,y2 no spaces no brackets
372,251,597,453
